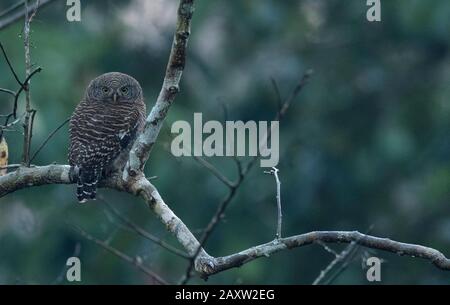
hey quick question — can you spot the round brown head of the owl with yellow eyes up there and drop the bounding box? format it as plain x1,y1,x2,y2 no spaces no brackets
86,72,142,103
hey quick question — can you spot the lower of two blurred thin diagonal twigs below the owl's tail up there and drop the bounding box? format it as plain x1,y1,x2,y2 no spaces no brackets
71,225,168,285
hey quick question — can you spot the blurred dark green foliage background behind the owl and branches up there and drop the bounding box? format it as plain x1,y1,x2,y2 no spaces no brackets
0,0,450,284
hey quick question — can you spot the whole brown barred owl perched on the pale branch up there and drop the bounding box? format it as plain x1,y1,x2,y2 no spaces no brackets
69,72,145,202
